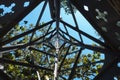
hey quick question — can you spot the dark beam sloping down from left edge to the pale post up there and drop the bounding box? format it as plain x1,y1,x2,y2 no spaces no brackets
0,58,53,71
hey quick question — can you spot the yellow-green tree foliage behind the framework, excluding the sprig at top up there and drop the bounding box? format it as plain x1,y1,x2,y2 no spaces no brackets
0,23,102,80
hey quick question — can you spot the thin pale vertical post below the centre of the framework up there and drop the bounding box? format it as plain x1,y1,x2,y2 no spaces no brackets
54,38,59,80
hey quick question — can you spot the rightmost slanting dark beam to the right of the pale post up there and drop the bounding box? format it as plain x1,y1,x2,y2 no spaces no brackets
68,48,83,80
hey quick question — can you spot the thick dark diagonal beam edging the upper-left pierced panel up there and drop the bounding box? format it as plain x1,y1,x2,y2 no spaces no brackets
0,0,43,39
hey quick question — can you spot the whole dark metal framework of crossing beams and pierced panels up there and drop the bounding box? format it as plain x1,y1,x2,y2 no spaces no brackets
0,0,120,80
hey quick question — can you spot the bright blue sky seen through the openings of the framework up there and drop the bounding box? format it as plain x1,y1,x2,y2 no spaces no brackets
0,2,104,80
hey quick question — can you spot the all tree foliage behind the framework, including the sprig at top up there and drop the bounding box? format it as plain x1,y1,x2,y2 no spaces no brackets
0,0,102,80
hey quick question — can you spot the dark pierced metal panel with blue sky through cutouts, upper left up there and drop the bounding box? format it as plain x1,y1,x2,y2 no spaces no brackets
0,0,42,38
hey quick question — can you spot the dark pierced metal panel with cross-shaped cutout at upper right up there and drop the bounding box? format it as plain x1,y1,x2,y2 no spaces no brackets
71,0,120,50
